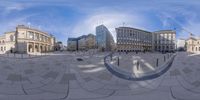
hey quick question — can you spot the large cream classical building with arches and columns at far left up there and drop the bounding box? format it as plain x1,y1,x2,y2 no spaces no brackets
0,25,55,53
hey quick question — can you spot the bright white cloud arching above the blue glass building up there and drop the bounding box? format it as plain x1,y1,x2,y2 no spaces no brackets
71,11,146,40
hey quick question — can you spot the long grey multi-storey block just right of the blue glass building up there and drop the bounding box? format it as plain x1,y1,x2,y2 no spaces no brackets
116,27,152,52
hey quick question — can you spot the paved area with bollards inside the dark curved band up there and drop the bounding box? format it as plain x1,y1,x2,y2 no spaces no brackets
111,52,172,73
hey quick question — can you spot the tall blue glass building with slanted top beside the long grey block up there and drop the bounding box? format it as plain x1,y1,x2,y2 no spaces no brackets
96,25,114,51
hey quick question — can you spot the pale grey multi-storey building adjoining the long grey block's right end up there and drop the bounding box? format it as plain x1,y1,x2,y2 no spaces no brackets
153,30,176,52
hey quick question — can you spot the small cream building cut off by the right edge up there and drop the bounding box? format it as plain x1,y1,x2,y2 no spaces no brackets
186,37,200,53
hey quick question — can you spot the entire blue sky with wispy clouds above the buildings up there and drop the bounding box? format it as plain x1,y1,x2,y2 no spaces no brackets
0,0,200,44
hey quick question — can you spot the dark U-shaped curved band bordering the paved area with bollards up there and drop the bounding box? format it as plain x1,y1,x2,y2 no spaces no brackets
104,53,176,81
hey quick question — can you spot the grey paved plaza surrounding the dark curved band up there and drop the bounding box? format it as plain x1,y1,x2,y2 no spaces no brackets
0,52,200,100
